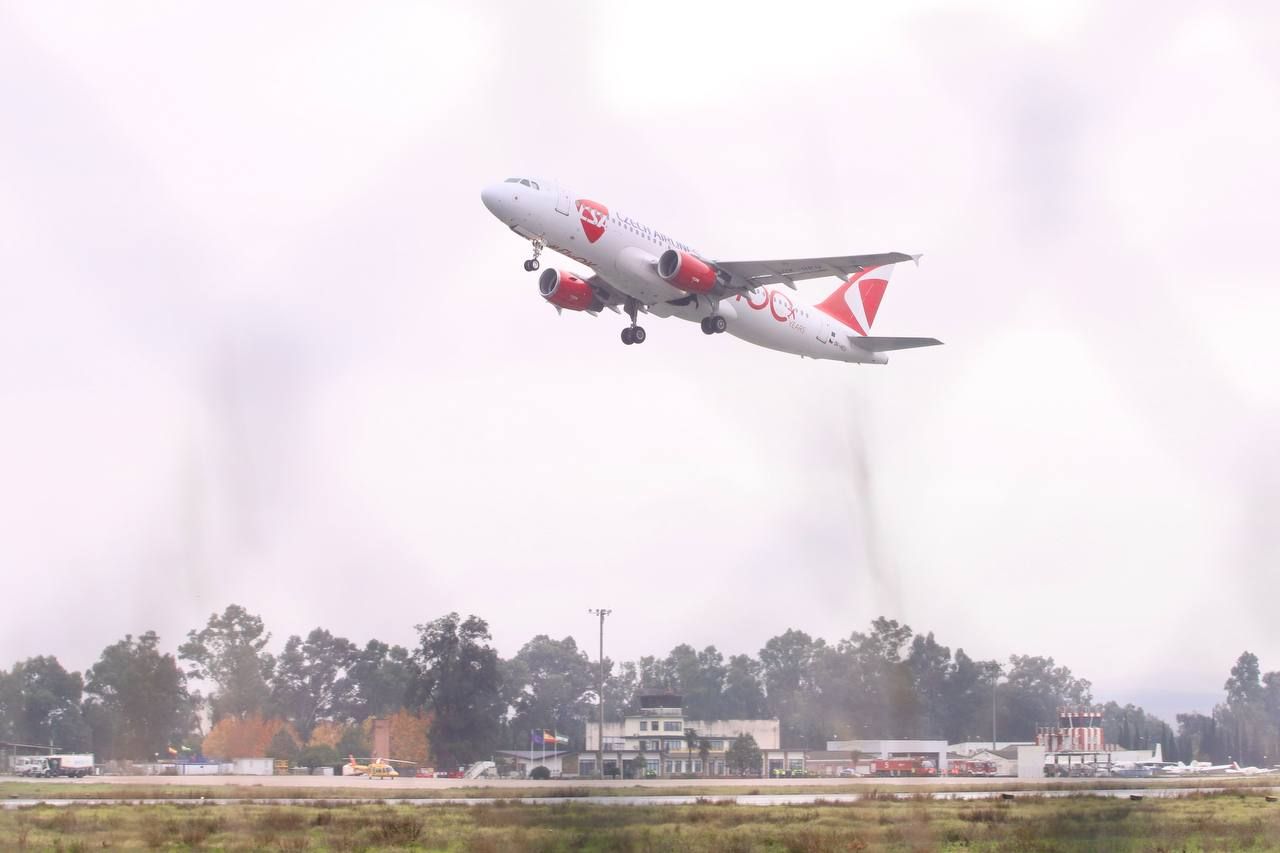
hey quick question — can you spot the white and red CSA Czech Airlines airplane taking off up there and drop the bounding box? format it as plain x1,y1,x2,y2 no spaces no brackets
480,178,942,364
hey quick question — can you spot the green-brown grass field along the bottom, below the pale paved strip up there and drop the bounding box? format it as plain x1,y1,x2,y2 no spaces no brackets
0,793,1280,853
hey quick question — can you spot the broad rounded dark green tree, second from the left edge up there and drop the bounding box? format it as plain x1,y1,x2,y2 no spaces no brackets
84,631,192,758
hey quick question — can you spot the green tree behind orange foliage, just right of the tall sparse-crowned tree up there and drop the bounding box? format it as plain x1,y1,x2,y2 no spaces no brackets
271,628,356,740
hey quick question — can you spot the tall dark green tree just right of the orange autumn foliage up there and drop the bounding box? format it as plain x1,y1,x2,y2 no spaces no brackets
413,613,503,767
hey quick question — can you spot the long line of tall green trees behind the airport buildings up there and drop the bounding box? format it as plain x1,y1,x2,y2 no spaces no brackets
0,605,1280,767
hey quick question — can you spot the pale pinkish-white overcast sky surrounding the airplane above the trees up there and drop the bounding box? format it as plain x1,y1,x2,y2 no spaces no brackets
0,1,1280,713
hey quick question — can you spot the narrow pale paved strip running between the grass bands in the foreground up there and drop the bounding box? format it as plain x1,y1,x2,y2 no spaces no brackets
0,788,1269,809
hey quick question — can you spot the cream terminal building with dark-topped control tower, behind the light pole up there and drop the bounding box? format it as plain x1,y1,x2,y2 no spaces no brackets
579,690,788,777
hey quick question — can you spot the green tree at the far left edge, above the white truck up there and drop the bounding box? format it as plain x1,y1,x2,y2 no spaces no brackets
0,656,92,751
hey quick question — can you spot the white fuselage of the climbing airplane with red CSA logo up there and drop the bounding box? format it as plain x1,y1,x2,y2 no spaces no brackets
481,182,887,364
